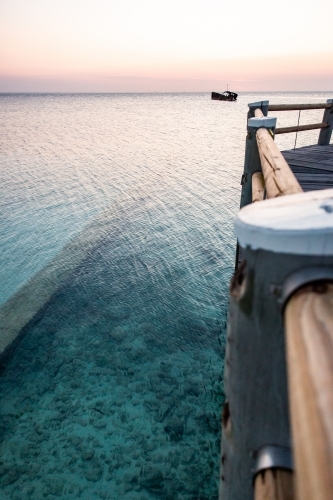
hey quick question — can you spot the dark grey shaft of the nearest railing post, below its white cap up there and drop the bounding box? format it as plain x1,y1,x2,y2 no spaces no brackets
220,248,332,500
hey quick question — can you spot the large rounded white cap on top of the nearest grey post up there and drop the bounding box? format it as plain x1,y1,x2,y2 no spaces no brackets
235,189,333,256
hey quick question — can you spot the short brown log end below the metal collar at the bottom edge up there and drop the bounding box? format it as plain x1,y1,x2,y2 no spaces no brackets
254,469,295,500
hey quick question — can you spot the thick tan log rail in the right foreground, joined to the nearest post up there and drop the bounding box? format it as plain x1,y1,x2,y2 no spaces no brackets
284,282,333,500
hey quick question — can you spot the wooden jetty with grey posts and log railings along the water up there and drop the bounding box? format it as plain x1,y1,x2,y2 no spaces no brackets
220,99,333,500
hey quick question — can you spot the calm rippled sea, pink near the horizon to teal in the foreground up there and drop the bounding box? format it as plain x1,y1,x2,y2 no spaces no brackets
0,93,331,500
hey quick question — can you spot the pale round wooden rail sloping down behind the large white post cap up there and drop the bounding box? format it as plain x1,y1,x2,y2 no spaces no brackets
256,128,302,198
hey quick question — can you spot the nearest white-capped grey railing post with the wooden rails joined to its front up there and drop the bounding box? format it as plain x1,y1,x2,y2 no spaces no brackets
220,189,333,500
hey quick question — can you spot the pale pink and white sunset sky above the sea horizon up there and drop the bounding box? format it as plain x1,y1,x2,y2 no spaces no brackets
0,0,333,92
